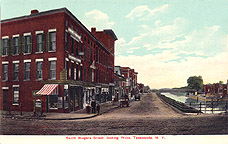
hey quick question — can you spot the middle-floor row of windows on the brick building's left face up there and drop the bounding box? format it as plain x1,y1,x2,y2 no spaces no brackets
2,61,56,81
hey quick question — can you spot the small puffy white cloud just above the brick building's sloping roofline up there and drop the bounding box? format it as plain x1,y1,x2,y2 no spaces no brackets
84,10,115,30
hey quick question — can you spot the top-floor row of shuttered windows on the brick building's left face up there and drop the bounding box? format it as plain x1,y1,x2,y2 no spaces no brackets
0,31,56,56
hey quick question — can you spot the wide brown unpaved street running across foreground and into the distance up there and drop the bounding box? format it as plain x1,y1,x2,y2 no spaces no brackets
1,94,228,135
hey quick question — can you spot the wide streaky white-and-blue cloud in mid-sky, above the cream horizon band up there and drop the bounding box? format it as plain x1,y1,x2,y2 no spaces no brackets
119,17,227,56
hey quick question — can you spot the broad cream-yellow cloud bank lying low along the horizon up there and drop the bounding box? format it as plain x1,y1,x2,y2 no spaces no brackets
115,51,228,88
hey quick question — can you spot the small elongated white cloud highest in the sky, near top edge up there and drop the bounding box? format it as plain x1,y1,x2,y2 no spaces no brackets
126,4,169,21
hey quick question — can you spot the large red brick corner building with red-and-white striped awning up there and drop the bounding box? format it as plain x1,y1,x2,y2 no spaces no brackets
0,8,117,112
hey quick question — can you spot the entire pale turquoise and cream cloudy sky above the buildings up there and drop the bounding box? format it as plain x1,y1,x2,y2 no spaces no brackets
1,0,228,88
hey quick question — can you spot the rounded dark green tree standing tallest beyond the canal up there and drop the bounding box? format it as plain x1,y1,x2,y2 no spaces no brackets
187,76,203,91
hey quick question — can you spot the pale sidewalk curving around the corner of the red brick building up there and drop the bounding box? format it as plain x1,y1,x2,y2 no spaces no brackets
0,102,119,120
